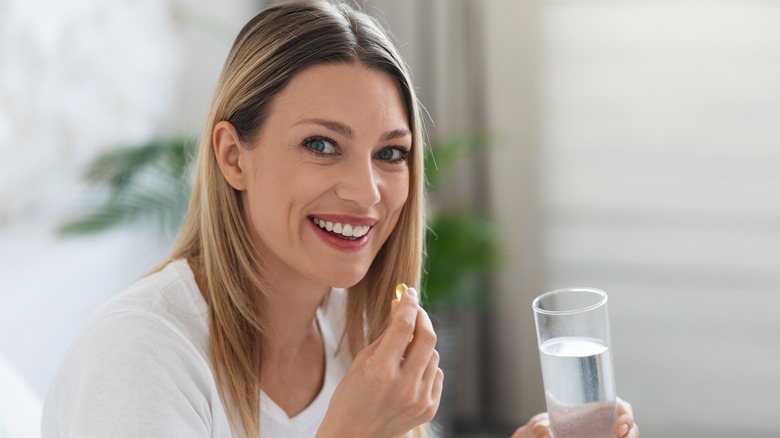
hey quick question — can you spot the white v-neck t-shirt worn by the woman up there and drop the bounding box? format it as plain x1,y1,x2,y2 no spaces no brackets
42,260,352,438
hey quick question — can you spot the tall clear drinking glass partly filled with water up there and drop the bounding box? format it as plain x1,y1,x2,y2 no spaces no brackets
533,288,617,438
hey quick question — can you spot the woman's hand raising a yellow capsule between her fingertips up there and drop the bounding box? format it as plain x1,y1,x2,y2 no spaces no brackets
317,288,444,438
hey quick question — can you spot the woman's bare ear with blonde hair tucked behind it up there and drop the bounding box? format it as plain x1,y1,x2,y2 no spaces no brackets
211,120,248,190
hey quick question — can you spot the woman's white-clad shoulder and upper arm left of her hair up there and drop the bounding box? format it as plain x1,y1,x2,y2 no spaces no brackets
44,262,218,436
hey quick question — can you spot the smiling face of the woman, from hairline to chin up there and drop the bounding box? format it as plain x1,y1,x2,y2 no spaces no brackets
242,63,412,287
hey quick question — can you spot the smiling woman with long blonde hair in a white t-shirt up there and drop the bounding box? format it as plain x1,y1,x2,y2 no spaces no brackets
43,1,636,437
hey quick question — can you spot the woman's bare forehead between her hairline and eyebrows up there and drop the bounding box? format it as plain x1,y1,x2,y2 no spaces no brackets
269,63,409,130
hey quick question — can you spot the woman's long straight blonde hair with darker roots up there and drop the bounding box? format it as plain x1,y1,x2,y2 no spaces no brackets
161,1,425,436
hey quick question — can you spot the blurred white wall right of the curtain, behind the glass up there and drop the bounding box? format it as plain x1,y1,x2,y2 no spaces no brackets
540,0,780,438
